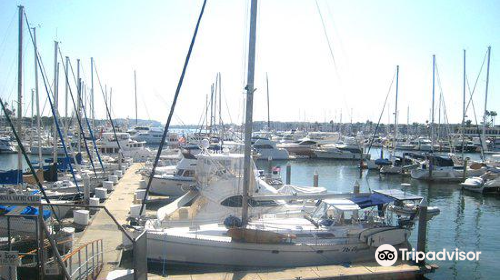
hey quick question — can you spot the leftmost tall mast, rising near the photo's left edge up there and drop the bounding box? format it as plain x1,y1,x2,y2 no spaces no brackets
17,6,24,174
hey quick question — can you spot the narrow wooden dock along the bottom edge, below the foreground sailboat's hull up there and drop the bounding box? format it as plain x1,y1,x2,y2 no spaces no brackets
152,262,437,280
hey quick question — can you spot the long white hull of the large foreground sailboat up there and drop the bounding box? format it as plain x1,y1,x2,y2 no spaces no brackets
148,233,376,267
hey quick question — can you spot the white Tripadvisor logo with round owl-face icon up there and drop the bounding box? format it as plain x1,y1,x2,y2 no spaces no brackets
375,244,481,266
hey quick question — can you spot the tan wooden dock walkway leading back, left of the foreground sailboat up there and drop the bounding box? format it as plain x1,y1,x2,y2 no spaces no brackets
74,163,142,279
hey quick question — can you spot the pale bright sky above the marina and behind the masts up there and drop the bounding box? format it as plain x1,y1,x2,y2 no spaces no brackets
0,0,500,124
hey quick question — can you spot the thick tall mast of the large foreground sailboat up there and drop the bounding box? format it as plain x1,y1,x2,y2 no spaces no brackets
242,0,257,225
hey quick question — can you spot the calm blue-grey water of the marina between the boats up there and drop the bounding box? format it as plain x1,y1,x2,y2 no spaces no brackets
0,150,500,279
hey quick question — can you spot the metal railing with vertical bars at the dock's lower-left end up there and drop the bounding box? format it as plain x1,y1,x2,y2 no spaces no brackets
62,239,104,280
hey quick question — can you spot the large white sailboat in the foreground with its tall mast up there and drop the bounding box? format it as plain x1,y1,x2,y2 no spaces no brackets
145,0,410,267
